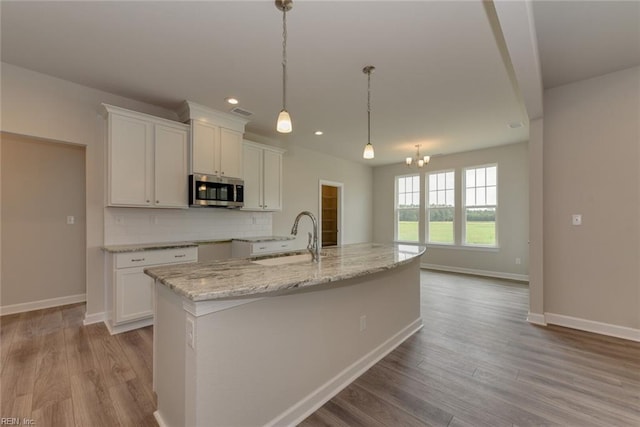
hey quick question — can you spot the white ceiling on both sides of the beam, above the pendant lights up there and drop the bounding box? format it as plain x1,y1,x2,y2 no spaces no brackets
1,0,640,165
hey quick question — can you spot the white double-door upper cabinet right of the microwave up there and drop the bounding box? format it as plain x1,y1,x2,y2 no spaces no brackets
242,141,284,211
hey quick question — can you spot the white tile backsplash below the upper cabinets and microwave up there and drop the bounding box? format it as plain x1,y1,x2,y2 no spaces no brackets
104,208,272,246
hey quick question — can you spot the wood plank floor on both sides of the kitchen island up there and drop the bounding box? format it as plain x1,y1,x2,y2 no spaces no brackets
0,271,640,427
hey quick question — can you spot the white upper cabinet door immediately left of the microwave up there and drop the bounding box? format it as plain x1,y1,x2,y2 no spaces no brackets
155,125,188,208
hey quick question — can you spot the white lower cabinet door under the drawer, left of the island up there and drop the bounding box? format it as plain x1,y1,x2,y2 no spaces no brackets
114,267,153,324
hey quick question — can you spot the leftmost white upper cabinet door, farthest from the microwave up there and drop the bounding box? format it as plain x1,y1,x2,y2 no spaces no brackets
108,114,153,206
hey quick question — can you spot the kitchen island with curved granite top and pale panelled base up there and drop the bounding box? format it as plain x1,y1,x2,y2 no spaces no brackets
145,243,424,427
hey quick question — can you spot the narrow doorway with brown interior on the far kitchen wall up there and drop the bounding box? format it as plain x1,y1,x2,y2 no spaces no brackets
320,180,343,248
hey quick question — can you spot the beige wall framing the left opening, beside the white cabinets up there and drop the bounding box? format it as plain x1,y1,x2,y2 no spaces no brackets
0,63,182,320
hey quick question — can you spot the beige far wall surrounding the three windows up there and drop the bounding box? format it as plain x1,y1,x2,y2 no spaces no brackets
373,143,529,279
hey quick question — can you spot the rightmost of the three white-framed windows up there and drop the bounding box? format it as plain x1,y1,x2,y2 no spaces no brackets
464,165,498,246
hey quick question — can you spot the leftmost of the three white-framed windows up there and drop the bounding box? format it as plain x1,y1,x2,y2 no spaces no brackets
396,175,420,242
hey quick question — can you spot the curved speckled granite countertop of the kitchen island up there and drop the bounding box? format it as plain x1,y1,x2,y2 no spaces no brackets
144,243,425,301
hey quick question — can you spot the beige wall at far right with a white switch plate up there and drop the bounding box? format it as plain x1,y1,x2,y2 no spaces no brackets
543,67,640,328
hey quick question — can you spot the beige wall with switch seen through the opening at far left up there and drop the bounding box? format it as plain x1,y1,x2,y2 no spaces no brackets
0,134,86,307
